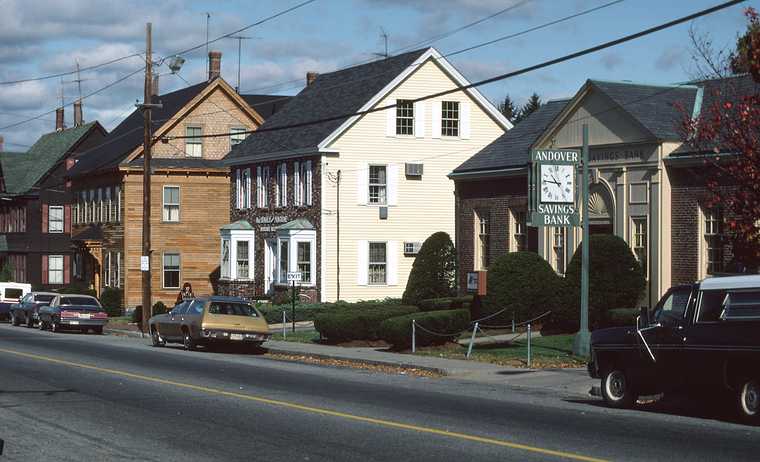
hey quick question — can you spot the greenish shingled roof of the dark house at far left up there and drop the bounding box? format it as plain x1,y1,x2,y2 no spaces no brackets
2,122,105,194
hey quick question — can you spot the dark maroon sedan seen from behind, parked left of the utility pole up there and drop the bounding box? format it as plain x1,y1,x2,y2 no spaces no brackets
38,294,108,334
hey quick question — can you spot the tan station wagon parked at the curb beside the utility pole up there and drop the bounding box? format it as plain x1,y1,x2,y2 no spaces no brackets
149,296,271,350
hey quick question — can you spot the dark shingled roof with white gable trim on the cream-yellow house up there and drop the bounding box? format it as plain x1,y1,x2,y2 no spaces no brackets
225,48,511,165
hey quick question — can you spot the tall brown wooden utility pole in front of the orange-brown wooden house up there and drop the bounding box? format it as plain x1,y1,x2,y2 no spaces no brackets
137,23,161,334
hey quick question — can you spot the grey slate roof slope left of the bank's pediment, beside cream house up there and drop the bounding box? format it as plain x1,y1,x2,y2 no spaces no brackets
452,99,569,176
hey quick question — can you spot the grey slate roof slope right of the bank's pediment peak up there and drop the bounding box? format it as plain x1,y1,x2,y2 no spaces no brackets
588,80,698,141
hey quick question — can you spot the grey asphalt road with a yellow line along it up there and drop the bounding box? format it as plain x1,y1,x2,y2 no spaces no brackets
0,324,760,461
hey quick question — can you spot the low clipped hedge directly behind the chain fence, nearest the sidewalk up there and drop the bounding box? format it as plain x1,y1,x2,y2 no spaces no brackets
379,310,470,350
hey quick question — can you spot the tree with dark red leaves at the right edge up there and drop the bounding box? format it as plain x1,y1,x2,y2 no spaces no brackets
682,8,760,269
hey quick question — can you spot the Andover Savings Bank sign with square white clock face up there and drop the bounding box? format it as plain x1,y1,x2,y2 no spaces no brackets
528,149,581,227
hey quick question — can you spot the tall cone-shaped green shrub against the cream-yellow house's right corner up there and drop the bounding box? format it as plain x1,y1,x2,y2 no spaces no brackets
401,231,456,305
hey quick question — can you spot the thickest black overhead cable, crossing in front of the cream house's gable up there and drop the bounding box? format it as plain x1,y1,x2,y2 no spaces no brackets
165,0,745,143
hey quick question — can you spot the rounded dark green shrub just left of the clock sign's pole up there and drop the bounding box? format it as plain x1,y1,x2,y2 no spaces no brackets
478,252,562,324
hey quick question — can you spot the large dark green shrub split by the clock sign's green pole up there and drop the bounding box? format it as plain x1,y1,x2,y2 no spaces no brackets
542,234,646,334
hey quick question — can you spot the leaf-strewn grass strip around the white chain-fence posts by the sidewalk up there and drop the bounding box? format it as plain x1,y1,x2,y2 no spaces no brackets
416,335,586,368
